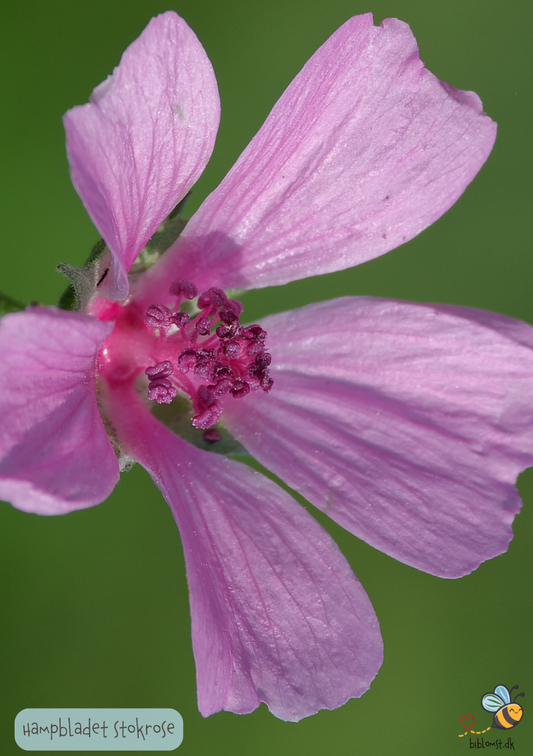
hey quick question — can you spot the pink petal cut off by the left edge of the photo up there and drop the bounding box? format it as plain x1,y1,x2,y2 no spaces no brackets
0,307,119,515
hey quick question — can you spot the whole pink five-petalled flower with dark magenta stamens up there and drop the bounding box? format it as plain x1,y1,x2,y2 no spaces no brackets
0,12,533,720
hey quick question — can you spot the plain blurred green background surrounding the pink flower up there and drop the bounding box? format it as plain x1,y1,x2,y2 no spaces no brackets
0,0,533,756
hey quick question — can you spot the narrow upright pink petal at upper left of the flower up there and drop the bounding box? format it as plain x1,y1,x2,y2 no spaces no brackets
64,11,220,299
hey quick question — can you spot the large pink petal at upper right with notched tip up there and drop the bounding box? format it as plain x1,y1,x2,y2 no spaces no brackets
140,13,496,301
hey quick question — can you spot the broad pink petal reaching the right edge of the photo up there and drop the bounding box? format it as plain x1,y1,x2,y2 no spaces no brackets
223,297,533,577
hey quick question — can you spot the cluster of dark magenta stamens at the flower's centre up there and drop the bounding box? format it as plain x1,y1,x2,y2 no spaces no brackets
144,278,274,430
